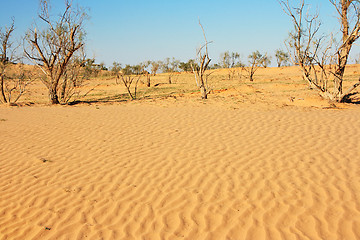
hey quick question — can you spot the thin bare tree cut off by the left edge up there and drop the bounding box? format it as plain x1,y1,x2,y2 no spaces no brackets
0,20,33,104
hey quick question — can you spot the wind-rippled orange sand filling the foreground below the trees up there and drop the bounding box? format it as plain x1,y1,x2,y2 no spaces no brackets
0,103,360,240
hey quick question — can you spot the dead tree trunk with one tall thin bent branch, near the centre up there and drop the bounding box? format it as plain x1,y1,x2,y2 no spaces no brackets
191,20,211,99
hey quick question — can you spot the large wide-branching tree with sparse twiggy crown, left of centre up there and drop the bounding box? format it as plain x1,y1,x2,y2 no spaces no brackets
25,0,87,104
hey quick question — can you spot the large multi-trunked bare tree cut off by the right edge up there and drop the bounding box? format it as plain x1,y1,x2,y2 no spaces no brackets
280,0,360,102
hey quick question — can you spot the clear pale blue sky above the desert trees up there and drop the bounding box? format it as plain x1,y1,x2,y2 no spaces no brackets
0,0,354,66
